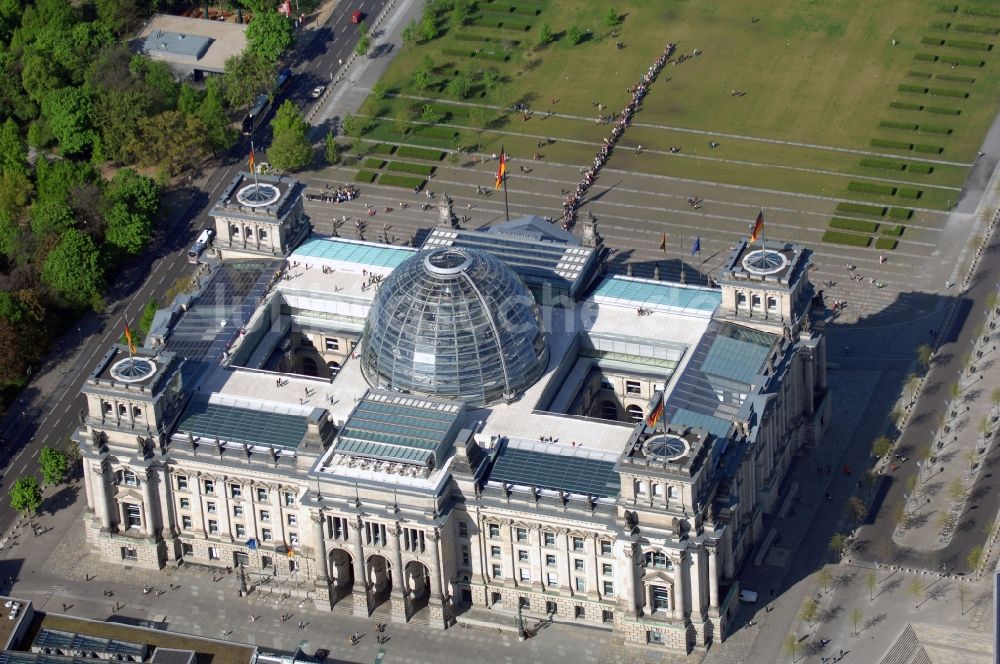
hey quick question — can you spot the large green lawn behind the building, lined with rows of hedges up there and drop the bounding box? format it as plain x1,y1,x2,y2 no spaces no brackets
350,0,1000,249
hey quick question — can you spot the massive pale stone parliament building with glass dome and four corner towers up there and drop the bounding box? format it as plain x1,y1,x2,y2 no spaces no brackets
75,174,830,652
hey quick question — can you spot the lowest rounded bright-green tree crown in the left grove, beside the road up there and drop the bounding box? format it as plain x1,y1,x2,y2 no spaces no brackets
42,229,104,310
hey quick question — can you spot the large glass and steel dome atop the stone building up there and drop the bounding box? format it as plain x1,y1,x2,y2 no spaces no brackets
361,247,548,406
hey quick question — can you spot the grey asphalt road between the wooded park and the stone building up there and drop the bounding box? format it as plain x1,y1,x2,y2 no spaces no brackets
0,0,385,532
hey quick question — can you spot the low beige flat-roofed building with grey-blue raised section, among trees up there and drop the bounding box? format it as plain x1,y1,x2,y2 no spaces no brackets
136,14,247,74
